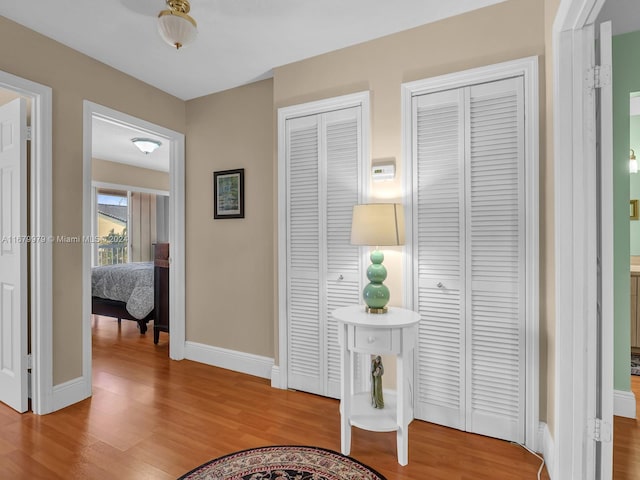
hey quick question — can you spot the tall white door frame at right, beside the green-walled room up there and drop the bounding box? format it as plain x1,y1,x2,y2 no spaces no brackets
550,0,613,480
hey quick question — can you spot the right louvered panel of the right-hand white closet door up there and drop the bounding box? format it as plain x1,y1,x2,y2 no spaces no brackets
465,78,525,442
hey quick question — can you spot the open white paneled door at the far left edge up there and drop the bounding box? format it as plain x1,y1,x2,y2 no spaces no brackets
0,98,28,412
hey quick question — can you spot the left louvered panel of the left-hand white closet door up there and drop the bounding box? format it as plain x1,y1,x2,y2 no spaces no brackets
287,117,323,394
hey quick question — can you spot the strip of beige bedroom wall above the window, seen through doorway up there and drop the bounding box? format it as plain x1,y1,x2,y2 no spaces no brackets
91,158,170,192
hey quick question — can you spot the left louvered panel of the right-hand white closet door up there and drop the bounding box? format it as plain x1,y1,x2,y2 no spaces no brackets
413,87,464,428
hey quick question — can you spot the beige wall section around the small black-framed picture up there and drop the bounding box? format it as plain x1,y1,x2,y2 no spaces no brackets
186,79,276,357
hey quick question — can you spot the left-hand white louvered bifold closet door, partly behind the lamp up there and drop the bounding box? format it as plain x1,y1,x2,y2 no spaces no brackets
287,107,362,398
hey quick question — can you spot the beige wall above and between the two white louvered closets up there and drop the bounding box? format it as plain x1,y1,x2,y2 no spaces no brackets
274,0,553,408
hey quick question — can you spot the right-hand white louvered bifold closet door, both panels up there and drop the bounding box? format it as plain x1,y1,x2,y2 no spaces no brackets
415,77,526,442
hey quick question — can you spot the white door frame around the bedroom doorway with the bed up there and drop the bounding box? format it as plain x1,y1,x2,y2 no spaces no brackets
82,100,185,396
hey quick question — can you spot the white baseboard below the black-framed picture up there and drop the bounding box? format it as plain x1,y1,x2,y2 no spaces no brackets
184,342,274,379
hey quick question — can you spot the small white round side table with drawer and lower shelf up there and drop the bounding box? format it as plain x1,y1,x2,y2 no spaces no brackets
333,305,420,465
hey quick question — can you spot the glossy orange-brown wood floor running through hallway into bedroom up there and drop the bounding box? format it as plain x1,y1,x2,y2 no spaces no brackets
0,317,640,480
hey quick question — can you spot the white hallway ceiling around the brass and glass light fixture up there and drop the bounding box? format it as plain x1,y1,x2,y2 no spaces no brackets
0,0,504,100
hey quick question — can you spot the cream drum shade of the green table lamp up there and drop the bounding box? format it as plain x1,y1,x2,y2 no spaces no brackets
351,203,404,247
